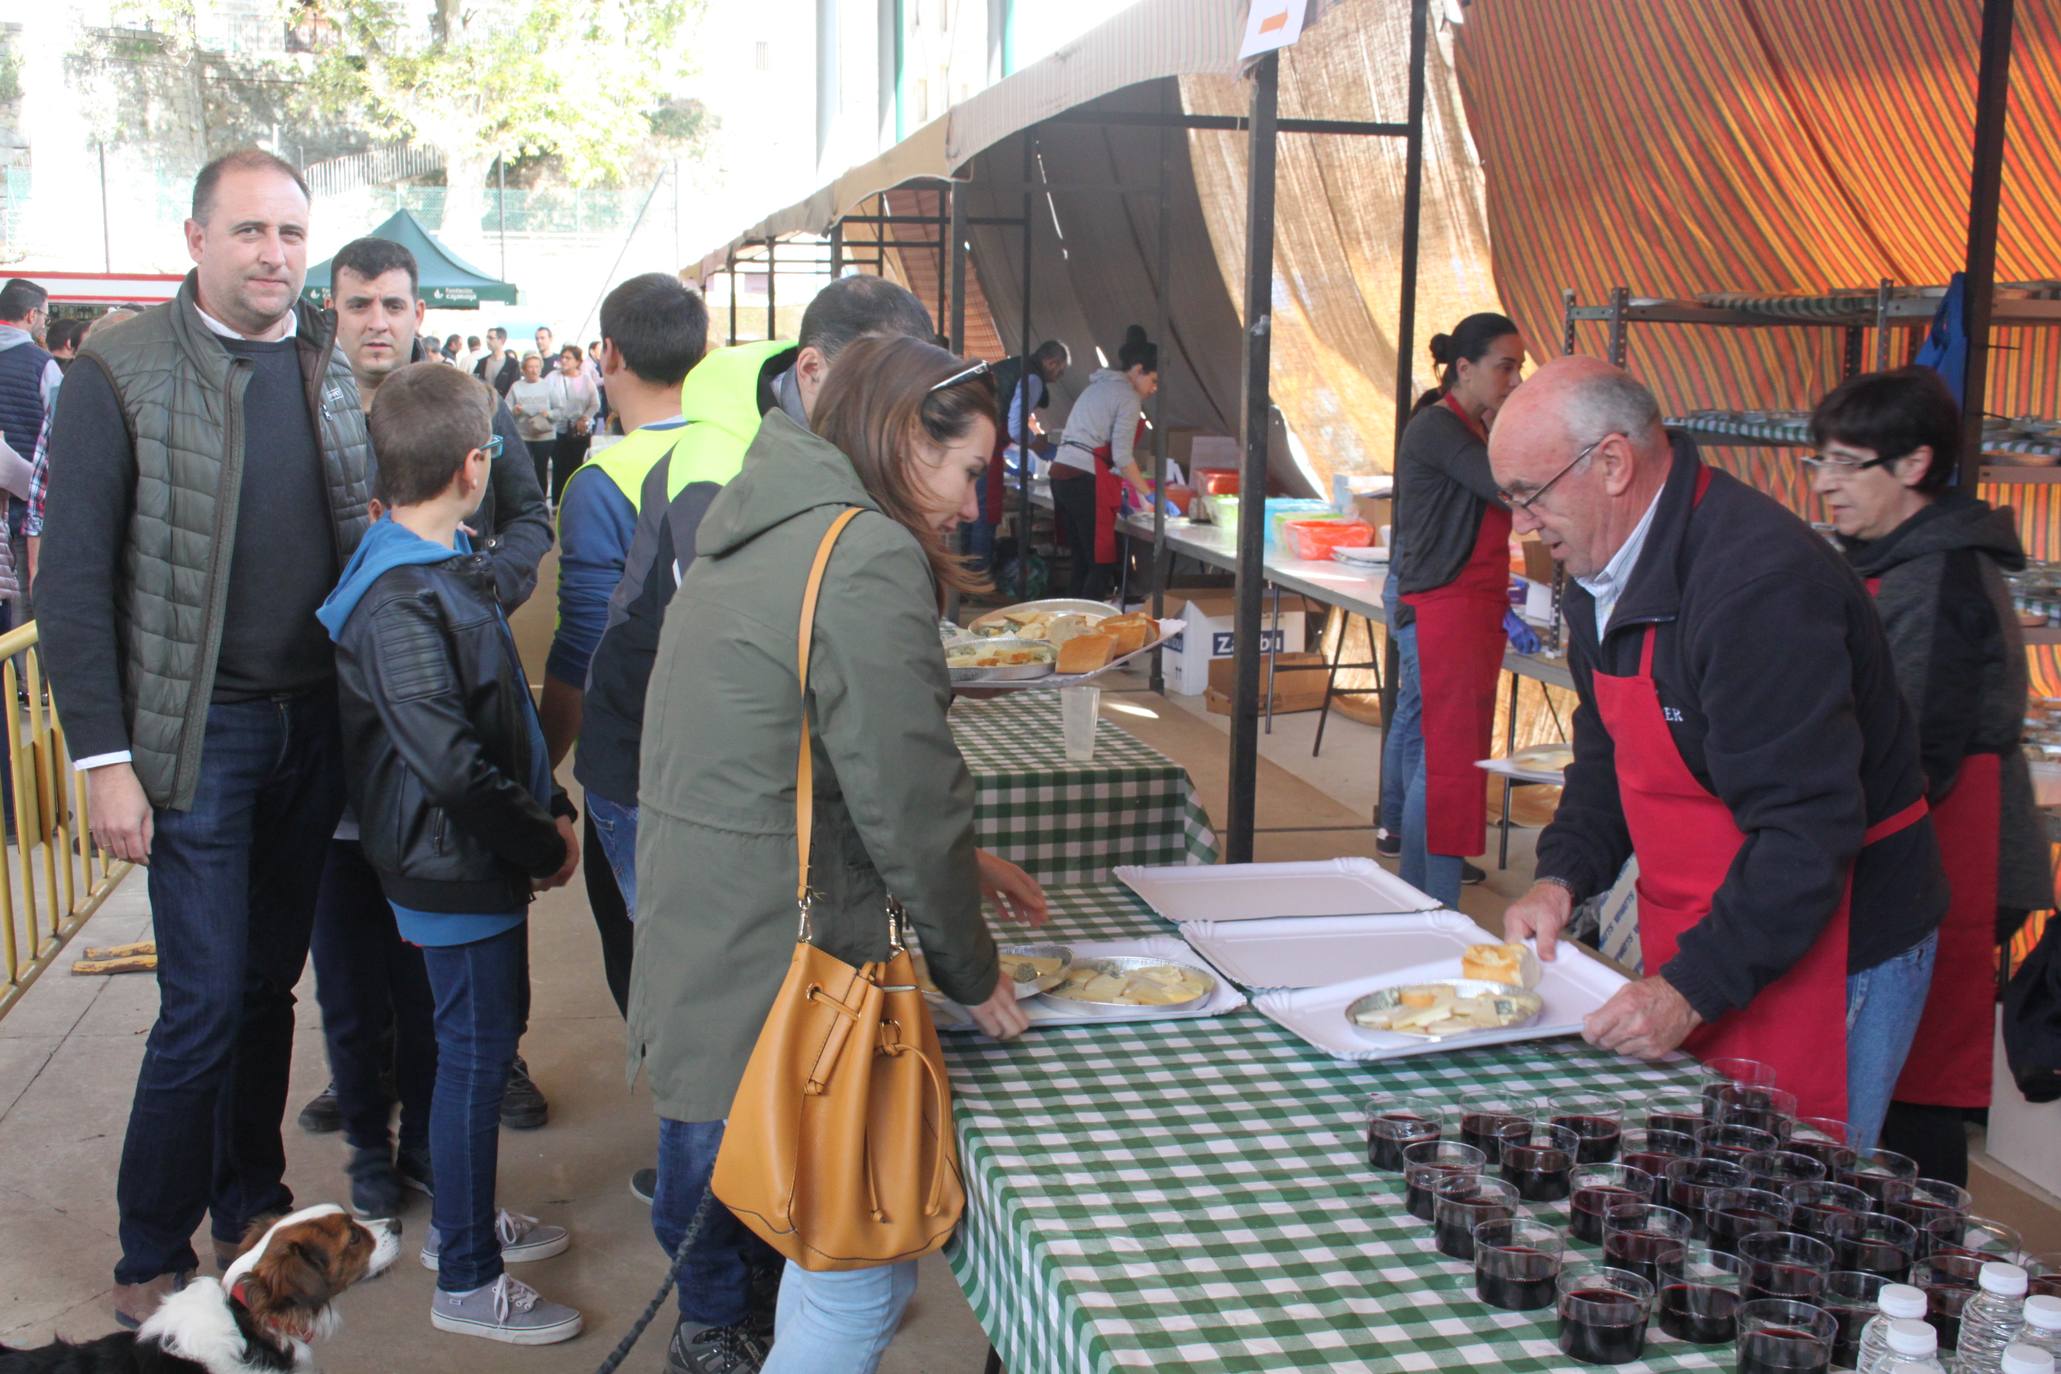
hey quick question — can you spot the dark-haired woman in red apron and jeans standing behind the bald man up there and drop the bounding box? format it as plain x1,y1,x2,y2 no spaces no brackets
1395,313,1525,906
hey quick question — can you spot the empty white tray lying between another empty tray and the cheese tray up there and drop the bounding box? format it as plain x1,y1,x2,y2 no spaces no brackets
1181,911,1490,987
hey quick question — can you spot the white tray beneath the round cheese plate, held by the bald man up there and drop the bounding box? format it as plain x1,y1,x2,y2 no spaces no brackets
1253,943,1626,1063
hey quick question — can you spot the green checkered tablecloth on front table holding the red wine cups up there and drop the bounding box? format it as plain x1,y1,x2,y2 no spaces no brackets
944,886,1735,1374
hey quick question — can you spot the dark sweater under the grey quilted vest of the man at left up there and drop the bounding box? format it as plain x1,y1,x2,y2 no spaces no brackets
37,327,336,704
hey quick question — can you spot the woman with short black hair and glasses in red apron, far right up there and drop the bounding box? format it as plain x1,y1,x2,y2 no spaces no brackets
1805,369,2053,1182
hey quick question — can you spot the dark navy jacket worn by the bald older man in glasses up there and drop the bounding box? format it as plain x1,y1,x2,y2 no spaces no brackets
1538,441,1948,1020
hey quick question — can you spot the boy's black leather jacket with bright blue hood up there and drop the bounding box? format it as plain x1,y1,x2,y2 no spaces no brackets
315,515,573,918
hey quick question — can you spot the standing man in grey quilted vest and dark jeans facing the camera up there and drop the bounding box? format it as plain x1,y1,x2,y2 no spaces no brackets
39,148,371,1327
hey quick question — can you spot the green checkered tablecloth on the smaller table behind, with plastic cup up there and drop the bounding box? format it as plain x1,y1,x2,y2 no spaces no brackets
952,692,1216,884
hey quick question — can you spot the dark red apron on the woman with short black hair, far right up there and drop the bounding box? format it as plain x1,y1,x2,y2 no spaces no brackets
1867,577,2003,1106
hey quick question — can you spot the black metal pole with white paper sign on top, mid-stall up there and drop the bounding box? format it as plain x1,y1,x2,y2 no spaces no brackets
1224,51,1280,863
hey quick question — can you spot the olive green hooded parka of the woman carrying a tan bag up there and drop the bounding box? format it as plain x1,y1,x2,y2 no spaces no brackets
629,410,998,1121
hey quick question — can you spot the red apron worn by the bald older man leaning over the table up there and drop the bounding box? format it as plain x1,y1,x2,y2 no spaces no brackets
1593,470,1925,1121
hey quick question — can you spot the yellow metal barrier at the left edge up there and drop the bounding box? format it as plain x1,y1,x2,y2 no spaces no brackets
0,620,130,1016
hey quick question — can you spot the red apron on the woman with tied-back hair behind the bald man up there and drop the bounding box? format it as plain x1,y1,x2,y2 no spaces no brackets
1404,396,1511,857
